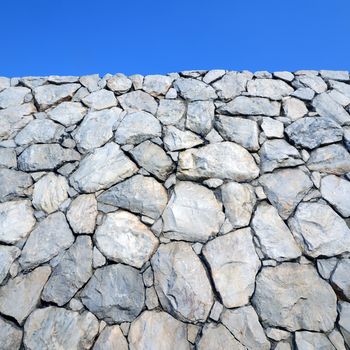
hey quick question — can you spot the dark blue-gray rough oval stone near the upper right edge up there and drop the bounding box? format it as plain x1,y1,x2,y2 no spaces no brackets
286,117,343,149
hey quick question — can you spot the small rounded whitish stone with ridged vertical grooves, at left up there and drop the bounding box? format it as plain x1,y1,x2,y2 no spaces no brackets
32,173,69,214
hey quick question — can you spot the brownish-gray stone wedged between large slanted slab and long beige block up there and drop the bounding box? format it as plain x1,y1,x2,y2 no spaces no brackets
130,141,175,181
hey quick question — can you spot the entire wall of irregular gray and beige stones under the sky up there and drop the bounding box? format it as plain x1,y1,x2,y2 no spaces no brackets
0,70,350,350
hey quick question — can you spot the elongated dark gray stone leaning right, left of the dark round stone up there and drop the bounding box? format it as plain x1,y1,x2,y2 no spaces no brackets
41,236,92,306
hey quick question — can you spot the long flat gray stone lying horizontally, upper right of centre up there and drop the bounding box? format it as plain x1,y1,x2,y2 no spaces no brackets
218,96,281,117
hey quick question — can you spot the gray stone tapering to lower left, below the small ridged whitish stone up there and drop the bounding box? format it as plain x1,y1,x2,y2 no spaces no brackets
19,212,74,269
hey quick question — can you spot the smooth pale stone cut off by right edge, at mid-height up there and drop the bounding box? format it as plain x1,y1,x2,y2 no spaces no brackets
321,175,350,217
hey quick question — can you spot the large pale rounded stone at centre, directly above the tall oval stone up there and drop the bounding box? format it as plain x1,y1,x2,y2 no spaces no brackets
163,181,224,242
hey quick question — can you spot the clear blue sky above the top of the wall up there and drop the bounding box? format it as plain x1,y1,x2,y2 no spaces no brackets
0,0,350,76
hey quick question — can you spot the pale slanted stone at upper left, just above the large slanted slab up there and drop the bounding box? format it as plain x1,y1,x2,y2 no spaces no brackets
72,107,122,152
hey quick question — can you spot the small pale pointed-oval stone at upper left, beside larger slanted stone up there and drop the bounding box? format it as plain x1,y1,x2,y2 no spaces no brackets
47,102,86,126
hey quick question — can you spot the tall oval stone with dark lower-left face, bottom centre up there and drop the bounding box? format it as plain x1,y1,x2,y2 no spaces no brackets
152,242,213,322
